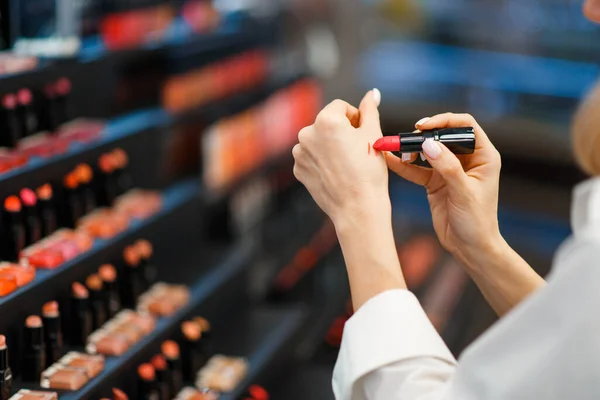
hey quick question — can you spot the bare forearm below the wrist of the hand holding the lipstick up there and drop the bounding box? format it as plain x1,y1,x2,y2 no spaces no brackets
458,237,545,316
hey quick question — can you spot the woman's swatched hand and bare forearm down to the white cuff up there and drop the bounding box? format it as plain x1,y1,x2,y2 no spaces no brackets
293,90,406,310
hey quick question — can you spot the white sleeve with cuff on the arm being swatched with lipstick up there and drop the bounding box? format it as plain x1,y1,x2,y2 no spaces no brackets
333,290,456,400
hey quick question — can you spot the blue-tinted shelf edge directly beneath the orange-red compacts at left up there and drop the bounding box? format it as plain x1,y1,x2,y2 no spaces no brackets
0,179,200,328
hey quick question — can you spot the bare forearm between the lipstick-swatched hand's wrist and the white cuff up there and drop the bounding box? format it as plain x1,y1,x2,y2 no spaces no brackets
334,201,406,310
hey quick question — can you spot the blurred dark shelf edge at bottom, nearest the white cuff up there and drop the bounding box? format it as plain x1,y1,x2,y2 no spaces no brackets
214,306,306,400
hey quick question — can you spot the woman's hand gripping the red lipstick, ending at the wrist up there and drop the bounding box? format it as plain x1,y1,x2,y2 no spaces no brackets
386,113,504,266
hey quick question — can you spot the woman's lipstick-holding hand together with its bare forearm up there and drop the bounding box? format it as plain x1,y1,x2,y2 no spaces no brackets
386,113,544,316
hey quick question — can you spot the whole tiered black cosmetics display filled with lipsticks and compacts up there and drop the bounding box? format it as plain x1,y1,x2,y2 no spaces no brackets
0,1,356,400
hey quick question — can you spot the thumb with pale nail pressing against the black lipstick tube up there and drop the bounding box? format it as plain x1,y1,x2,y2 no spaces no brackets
423,139,468,193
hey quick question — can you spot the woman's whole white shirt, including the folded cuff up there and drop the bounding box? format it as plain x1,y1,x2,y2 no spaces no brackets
333,178,600,400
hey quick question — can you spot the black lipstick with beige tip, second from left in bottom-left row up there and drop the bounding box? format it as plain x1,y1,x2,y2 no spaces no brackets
21,315,46,382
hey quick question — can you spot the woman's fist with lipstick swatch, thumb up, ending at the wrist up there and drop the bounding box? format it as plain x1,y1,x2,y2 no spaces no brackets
292,89,391,226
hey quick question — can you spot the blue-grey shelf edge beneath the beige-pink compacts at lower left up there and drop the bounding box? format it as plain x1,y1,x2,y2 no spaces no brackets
60,239,255,400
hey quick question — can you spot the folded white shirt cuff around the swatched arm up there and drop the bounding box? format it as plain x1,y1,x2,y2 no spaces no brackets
333,290,456,399
